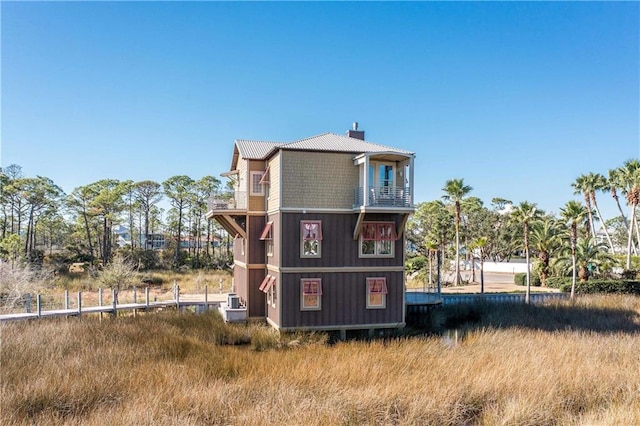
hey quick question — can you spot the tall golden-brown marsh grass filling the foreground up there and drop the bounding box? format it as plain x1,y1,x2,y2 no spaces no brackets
0,296,640,425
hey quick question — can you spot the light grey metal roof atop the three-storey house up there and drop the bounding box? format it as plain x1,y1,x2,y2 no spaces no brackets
236,133,413,160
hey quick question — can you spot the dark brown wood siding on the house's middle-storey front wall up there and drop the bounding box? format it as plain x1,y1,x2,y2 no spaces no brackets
280,213,404,268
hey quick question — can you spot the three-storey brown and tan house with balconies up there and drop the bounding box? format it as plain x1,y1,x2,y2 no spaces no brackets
207,123,415,334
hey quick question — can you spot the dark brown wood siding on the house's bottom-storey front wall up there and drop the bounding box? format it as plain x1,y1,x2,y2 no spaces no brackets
272,270,404,329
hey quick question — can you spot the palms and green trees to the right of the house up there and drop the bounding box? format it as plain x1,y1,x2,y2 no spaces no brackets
407,159,640,302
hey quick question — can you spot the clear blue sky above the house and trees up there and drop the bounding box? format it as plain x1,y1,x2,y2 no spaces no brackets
0,1,640,221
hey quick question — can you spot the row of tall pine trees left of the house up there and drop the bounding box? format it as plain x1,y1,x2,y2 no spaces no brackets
0,164,230,267
